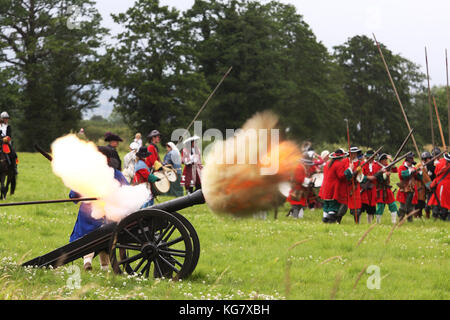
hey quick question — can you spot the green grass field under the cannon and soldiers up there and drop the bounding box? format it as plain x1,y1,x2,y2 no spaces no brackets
0,153,450,300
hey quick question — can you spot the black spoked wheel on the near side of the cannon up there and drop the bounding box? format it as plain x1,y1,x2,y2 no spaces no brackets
110,209,193,280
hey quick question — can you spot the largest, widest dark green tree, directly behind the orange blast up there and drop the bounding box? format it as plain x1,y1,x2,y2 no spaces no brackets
185,0,346,141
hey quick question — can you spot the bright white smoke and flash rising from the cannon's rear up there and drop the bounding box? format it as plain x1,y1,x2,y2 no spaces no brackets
52,134,150,221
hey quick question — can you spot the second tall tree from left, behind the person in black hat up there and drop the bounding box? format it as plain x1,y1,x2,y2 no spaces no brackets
107,0,209,139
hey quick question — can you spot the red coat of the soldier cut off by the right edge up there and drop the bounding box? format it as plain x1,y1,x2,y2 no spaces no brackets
428,158,450,209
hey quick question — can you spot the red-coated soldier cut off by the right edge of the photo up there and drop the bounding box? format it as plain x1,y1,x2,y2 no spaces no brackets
428,152,450,220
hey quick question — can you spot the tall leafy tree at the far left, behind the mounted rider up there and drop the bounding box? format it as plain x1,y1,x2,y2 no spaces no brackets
0,0,106,151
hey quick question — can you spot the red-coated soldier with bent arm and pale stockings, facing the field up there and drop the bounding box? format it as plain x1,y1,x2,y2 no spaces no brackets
375,153,398,223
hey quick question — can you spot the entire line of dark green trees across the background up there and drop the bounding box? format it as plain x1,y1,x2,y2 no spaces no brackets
0,0,448,152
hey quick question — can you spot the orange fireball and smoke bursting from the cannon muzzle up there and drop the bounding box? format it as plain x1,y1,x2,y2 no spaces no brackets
202,112,301,216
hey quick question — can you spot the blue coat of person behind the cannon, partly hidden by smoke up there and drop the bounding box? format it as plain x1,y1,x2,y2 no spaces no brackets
69,169,128,242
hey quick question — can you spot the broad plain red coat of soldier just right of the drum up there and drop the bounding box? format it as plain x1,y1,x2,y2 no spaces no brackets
319,159,348,205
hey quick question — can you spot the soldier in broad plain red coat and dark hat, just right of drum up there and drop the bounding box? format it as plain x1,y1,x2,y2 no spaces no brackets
319,149,348,223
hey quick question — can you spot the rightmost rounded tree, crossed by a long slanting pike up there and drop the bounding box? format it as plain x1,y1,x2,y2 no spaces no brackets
334,36,426,152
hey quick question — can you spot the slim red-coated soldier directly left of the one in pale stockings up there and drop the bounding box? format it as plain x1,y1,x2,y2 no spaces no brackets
361,150,381,223
